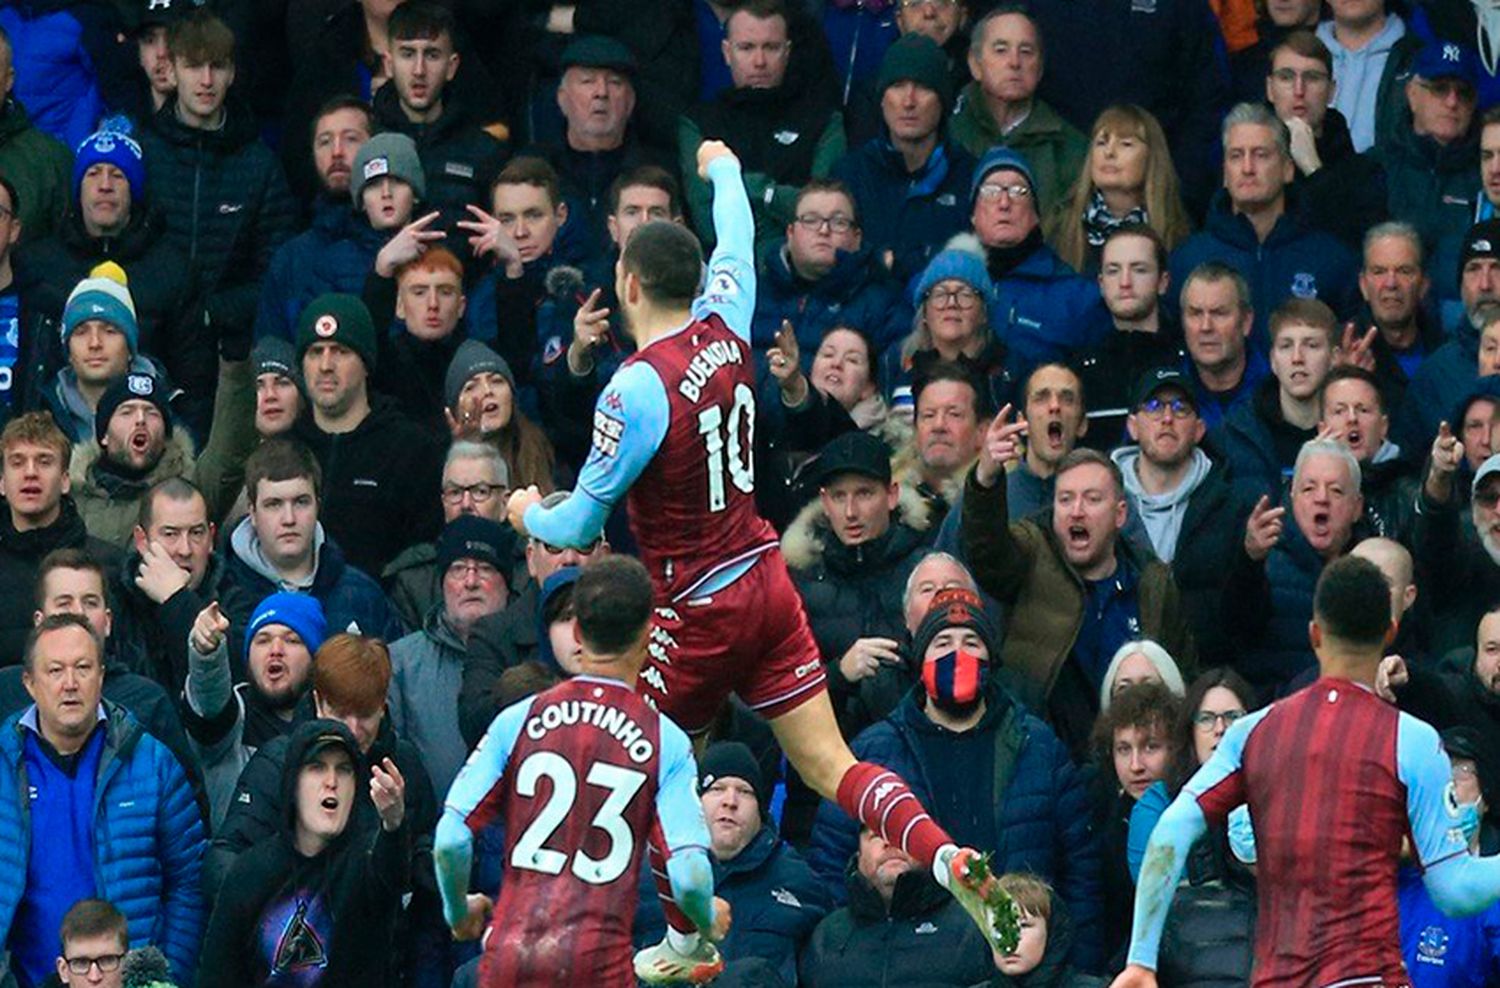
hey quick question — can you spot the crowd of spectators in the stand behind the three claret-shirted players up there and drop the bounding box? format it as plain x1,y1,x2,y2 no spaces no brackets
0,0,1500,988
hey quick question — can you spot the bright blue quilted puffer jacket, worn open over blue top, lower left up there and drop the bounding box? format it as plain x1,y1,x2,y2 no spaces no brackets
0,700,209,985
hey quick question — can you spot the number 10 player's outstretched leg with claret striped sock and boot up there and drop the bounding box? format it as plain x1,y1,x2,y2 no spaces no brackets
771,691,1019,954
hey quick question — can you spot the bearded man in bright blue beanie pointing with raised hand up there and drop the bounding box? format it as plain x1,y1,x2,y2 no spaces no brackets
183,594,329,833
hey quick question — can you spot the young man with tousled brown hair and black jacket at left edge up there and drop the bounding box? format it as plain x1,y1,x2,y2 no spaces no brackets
0,412,120,666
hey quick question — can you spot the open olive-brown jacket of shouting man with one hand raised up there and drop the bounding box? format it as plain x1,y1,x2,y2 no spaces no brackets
962,469,1197,751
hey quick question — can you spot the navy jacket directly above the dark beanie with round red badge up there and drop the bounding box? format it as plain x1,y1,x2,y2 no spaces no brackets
255,198,390,342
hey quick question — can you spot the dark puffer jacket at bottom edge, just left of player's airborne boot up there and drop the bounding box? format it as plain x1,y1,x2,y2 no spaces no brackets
798,864,995,988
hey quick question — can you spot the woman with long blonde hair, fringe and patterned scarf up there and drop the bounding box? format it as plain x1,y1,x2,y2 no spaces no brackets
1047,103,1193,274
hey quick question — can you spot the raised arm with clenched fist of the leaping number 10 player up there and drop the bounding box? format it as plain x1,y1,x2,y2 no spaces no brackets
693,141,755,343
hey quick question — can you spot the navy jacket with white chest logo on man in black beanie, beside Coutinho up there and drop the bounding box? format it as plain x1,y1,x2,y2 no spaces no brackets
714,825,834,985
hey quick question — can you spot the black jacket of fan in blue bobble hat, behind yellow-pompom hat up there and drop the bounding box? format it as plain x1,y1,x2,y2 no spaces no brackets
15,202,219,428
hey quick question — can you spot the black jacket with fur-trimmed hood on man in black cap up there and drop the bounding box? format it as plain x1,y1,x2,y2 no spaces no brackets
782,487,932,738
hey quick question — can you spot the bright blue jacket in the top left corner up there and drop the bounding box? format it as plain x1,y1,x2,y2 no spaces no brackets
0,0,123,151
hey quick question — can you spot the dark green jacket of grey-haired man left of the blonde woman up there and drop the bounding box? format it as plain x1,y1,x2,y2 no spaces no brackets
948,82,1089,216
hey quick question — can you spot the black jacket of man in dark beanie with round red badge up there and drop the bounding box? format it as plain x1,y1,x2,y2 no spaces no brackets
294,394,443,576
